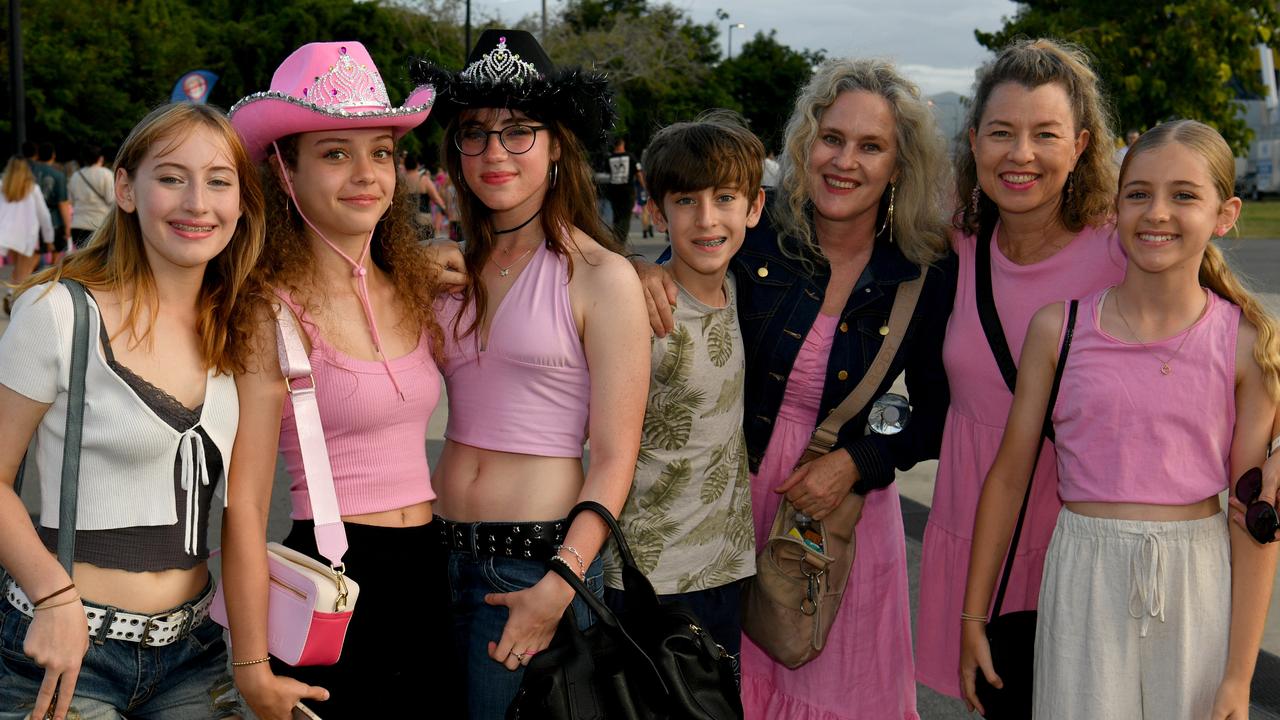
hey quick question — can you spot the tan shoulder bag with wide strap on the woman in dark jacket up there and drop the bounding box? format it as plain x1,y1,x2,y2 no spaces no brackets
742,266,925,669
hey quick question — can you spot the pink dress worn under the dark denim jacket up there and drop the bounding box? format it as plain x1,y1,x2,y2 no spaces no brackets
742,314,919,720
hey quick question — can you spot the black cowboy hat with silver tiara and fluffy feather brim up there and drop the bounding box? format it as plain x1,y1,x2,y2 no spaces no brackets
408,29,617,149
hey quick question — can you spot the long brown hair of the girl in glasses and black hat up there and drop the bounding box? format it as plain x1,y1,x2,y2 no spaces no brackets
442,109,621,340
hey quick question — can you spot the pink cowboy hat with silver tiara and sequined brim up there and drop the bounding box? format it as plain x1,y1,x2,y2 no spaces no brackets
230,41,435,161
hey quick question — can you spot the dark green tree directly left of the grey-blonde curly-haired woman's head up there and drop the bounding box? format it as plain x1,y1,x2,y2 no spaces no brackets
716,29,823,152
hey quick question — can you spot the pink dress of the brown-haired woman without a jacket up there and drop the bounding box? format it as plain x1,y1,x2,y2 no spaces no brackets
915,225,1125,697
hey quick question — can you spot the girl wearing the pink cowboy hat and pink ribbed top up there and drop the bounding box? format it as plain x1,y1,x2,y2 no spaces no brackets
223,42,461,720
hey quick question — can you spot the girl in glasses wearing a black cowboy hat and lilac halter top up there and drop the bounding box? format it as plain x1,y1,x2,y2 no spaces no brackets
411,31,649,720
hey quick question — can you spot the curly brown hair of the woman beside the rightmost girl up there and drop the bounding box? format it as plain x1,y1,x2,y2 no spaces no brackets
955,38,1116,234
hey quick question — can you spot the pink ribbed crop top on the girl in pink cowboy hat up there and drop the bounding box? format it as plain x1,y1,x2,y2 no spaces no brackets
278,288,440,520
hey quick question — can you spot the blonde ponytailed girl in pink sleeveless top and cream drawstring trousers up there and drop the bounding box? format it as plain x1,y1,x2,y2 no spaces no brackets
956,120,1280,720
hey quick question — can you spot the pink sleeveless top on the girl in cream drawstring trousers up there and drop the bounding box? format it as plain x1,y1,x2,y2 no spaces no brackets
1053,291,1240,505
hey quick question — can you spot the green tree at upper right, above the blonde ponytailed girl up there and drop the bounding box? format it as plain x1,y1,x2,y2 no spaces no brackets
974,0,1280,154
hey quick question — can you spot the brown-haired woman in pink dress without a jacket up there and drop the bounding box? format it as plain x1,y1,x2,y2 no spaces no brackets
916,40,1125,698
